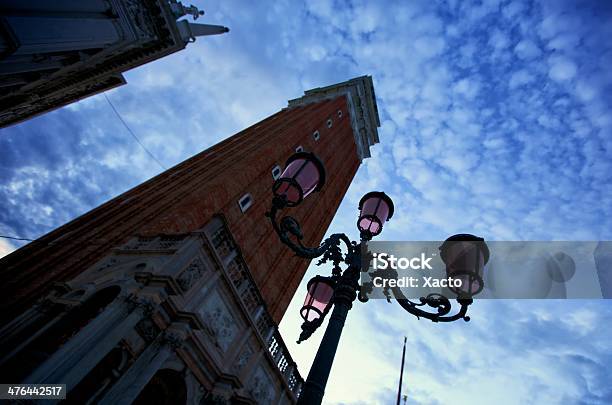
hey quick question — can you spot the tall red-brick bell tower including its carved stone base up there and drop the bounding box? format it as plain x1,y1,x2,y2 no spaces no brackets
0,76,380,403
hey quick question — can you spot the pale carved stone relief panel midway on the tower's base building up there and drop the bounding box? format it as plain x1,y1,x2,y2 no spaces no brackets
200,291,238,352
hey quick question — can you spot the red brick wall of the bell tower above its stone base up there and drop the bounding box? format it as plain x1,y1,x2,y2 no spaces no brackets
0,97,359,324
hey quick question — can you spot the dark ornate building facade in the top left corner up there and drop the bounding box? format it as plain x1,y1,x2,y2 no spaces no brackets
0,0,229,128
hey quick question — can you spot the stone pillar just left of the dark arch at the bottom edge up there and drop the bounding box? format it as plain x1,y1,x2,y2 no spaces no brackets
99,325,186,405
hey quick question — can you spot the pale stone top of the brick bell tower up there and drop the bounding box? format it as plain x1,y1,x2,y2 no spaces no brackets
287,76,380,160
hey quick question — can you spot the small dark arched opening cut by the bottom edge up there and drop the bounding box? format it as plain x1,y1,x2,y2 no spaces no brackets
132,368,187,405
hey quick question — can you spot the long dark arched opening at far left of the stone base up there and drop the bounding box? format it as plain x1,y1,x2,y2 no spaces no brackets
0,286,121,382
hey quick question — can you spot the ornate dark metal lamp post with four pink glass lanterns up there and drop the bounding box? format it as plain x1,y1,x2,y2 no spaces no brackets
266,152,489,405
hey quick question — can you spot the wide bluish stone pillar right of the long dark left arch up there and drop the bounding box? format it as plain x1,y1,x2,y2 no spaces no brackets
24,298,152,391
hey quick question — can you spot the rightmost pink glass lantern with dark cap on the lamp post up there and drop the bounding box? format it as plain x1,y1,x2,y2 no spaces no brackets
440,234,489,298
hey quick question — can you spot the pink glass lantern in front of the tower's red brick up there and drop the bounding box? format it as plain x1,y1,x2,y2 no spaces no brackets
272,152,325,207
